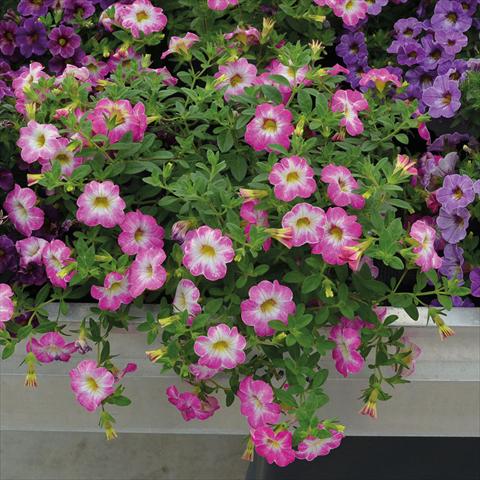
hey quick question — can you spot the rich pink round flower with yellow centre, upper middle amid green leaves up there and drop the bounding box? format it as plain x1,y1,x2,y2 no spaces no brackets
245,103,294,152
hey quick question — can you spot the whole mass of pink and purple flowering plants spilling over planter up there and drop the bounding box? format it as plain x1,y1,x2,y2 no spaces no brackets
0,0,480,466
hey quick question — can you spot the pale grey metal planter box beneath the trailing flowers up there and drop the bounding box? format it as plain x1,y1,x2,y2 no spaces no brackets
0,304,480,436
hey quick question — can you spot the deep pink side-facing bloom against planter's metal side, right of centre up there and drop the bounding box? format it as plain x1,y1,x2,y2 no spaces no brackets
329,324,365,377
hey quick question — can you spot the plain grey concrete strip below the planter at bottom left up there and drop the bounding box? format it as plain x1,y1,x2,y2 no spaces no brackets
0,431,248,480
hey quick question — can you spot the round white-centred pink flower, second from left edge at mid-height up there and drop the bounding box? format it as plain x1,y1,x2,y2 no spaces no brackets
77,180,125,228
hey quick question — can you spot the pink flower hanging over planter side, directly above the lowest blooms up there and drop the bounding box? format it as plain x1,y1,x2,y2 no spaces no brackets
237,377,280,428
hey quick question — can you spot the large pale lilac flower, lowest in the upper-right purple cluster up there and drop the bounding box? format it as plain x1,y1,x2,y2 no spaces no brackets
422,75,461,118
